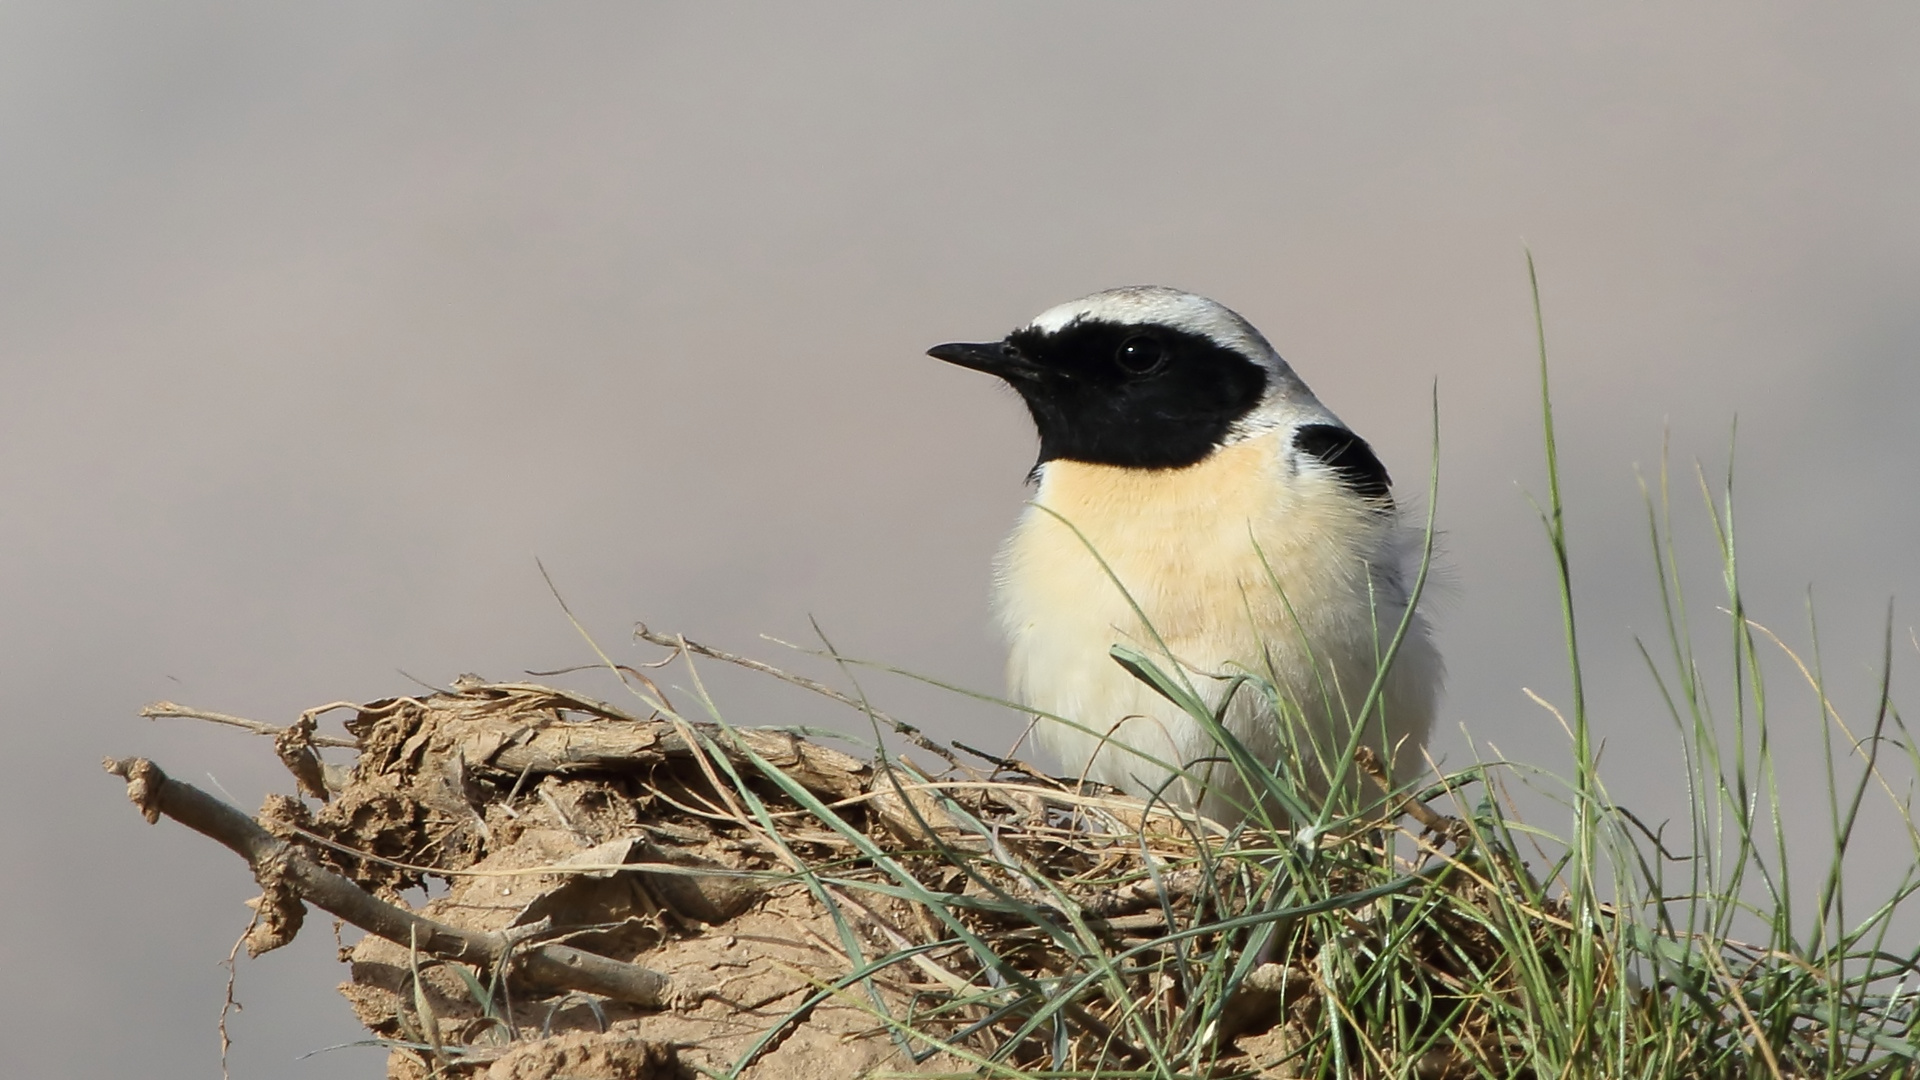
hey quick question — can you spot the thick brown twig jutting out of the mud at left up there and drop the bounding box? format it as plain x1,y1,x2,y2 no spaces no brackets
104,757,680,1009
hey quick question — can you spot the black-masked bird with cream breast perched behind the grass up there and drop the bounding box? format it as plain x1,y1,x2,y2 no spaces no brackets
927,284,1444,826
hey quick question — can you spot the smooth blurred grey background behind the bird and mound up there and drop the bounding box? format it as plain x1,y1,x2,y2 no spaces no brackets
0,0,1920,1078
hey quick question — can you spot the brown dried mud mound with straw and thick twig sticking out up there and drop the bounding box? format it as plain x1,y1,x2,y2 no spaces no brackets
108,678,1305,1080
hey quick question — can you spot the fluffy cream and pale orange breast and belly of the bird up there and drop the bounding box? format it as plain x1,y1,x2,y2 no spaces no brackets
996,432,1440,822
